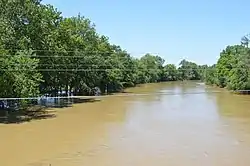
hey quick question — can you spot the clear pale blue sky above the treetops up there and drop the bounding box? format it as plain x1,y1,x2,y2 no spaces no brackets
43,0,250,64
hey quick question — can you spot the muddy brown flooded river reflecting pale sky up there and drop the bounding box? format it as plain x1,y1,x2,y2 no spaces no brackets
0,82,250,166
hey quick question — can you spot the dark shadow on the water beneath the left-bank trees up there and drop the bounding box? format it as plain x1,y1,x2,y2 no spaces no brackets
0,98,98,124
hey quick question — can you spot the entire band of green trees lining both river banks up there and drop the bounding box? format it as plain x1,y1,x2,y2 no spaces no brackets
0,0,249,97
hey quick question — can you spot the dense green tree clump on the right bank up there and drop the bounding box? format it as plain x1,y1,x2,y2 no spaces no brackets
206,44,250,90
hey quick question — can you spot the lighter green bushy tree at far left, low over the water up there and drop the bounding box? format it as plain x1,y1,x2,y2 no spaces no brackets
0,51,43,97
